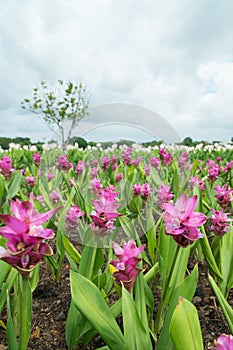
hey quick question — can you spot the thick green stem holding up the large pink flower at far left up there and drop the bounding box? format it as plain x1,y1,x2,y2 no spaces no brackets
18,274,29,350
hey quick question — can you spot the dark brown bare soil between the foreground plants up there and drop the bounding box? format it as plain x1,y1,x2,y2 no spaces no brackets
0,246,233,350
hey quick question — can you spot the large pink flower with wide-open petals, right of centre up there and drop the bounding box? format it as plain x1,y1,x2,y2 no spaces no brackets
162,194,206,247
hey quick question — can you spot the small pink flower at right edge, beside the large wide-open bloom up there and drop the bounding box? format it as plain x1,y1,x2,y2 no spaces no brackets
209,209,232,236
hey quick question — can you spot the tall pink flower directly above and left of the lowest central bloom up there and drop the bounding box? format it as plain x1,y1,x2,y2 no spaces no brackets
90,186,121,235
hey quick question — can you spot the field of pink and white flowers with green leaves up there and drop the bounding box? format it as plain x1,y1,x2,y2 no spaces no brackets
0,143,233,350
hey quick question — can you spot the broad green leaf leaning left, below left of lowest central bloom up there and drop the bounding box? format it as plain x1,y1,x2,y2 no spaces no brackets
70,271,125,350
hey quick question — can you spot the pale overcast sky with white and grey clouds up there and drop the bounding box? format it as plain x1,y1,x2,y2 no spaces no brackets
0,0,233,141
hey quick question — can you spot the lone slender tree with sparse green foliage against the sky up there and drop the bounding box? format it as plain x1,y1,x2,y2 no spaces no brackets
21,80,89,147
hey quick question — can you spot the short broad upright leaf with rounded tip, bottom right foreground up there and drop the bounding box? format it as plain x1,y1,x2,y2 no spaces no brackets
170,297,204,350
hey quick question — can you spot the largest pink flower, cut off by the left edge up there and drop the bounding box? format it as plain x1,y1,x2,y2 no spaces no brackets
0,194,61,274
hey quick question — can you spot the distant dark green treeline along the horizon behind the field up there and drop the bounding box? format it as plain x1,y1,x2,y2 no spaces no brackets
0,136,228,150
